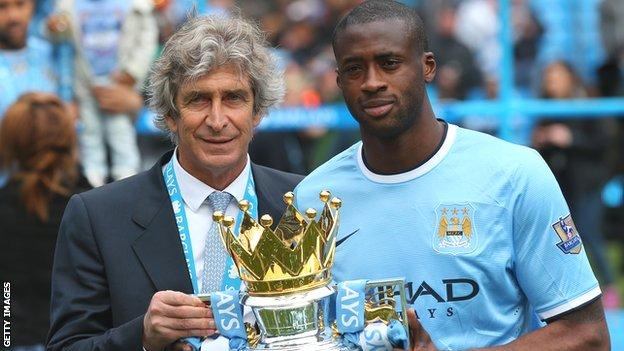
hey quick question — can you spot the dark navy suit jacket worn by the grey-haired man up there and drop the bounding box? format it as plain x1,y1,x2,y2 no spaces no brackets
47,152,302,351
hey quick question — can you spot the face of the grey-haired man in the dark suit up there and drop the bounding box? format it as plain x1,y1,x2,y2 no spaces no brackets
167,66,260,179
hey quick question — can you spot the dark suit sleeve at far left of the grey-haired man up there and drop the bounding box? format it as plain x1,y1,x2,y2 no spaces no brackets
47,195,143,351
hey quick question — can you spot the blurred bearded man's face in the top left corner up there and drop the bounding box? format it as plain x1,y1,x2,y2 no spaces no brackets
0,0,34,49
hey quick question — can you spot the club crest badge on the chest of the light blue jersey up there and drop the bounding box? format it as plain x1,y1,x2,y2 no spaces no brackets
432,204,478,255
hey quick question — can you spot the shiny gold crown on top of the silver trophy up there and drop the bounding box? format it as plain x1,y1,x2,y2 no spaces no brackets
213,190,342,296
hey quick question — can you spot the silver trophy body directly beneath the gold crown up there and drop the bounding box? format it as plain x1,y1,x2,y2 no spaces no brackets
242,286,350,351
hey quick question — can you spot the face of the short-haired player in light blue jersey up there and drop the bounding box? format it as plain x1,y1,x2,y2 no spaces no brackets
334,20,435,138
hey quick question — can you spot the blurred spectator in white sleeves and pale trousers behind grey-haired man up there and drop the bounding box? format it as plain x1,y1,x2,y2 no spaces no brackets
51,0,158,186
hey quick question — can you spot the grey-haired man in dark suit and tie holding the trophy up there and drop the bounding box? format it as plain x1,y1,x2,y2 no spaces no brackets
47,17,301,351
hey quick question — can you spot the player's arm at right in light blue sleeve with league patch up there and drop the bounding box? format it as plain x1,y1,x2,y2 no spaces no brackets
504,151,609,350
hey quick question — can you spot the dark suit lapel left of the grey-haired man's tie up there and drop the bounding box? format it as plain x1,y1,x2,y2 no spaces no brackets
132,152,193,293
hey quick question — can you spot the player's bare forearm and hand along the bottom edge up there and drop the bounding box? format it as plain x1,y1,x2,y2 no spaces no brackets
408,299,611,351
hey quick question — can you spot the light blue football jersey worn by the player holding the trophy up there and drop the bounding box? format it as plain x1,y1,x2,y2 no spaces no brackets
295,125,600,350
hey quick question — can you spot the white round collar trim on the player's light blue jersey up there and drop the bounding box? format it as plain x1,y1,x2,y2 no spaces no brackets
357,123,457,184
